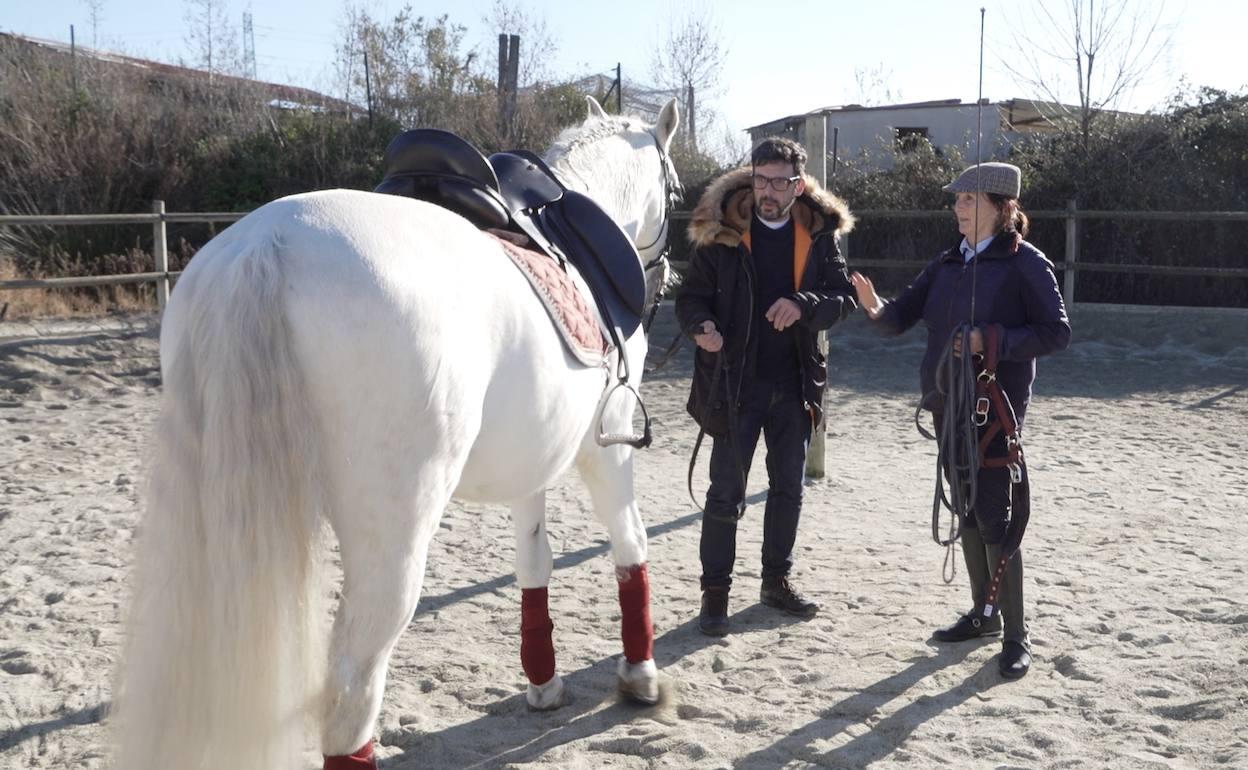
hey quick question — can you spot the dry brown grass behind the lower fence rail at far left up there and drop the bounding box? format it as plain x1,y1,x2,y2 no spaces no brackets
0,257,156,321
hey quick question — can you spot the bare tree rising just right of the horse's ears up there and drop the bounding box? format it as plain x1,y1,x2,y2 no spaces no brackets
650,4,728,152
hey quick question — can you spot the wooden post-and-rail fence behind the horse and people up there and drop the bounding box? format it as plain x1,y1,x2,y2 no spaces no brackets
0,201,1248,309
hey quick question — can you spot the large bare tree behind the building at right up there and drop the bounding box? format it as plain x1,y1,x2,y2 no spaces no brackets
1002,0,1171,147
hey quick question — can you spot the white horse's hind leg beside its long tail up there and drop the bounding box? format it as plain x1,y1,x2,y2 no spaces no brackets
321,462,458,770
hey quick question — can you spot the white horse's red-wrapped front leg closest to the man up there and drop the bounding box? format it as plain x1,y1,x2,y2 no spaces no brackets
578,446,659,705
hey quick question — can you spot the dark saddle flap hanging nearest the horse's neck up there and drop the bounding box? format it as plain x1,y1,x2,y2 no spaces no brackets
539,190,645,334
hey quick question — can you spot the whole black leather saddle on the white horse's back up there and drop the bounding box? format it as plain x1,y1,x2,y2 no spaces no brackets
376,129,645,336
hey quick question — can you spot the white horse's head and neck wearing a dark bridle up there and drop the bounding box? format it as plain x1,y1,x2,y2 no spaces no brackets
545,96,683,321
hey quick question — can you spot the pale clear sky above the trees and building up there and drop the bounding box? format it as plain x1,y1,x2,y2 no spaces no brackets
0,0,1248,154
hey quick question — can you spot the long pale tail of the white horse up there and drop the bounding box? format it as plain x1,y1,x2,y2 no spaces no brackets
114,230,328,770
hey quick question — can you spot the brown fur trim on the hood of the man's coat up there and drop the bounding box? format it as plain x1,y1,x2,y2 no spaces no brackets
688,166,854,247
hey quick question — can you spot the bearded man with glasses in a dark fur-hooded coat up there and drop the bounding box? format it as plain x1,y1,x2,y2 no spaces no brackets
676,137,856,635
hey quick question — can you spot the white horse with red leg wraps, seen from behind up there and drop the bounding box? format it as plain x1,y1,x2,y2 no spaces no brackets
112,100,679,770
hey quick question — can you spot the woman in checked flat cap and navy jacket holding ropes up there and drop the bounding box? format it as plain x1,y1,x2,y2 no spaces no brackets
850,162,1071,679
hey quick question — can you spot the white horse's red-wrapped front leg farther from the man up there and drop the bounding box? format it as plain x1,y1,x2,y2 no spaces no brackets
512,490,563,710
